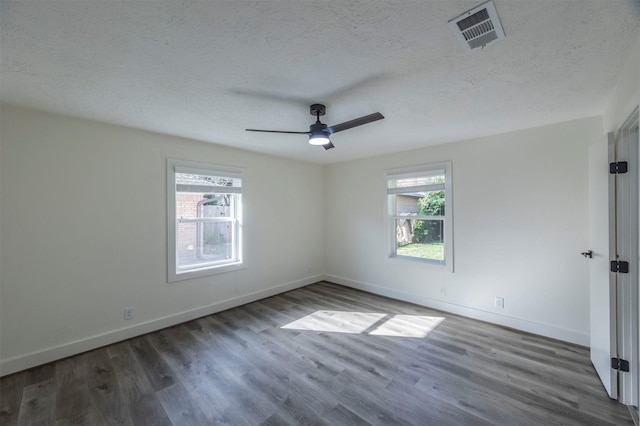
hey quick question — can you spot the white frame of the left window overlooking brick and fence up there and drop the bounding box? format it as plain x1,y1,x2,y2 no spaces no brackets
167,158,246,282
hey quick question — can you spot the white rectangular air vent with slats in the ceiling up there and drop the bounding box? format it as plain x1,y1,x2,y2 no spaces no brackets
449,0,504,50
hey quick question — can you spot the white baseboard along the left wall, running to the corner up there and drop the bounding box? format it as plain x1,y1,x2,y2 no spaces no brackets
0,275,322,376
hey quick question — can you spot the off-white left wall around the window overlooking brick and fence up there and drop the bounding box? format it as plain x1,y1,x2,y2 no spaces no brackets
0,105,324,374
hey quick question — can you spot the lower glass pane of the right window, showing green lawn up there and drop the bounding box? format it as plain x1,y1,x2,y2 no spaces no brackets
396,218,444,261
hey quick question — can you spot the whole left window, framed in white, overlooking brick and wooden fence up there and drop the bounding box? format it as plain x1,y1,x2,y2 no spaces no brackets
167,160,243,282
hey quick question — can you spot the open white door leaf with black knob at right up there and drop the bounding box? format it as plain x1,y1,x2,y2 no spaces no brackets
589,133,618,399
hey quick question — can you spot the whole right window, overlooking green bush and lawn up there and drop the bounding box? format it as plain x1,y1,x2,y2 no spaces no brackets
386,162,453,271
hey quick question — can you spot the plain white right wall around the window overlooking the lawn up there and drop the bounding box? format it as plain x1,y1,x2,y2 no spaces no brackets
325,117,606,345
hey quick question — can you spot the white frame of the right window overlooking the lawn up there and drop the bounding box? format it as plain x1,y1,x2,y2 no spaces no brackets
384,161,453,272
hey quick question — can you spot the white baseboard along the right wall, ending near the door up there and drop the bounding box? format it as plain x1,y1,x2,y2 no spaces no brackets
324,274,590,346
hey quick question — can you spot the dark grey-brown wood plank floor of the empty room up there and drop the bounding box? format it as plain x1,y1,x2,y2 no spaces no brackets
0,282,633,426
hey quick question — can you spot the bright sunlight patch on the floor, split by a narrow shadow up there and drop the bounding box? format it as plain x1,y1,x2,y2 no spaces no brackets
280,311,444,338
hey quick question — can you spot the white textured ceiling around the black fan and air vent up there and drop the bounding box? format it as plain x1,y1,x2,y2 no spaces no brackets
0,0,640,164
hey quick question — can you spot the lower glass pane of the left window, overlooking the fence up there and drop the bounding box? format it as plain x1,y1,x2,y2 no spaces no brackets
177,222,234,268
